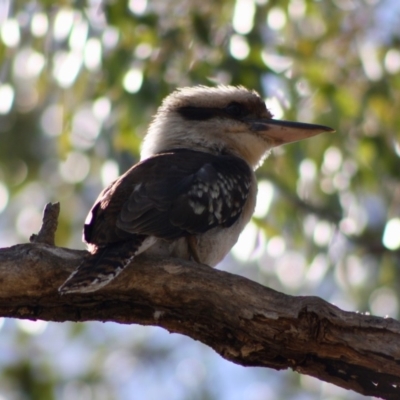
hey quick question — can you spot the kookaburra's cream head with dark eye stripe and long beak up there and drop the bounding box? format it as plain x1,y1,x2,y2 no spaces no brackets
141,86,334,168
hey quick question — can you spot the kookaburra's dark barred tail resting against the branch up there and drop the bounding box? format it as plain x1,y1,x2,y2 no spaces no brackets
58,235,145,294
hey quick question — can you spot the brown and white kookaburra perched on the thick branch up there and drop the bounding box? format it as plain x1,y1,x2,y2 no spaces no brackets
59,85,334,294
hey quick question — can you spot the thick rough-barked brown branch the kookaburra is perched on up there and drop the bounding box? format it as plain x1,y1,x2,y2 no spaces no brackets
0,207,400,399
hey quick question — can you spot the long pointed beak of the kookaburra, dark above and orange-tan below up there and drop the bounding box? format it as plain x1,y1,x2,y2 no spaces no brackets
251,119,335,146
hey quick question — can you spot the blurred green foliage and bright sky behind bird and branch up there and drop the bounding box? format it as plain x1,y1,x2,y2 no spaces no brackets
0,0,400,400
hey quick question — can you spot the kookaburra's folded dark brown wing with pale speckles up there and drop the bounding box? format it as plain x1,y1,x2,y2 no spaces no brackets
85,150,251,246
